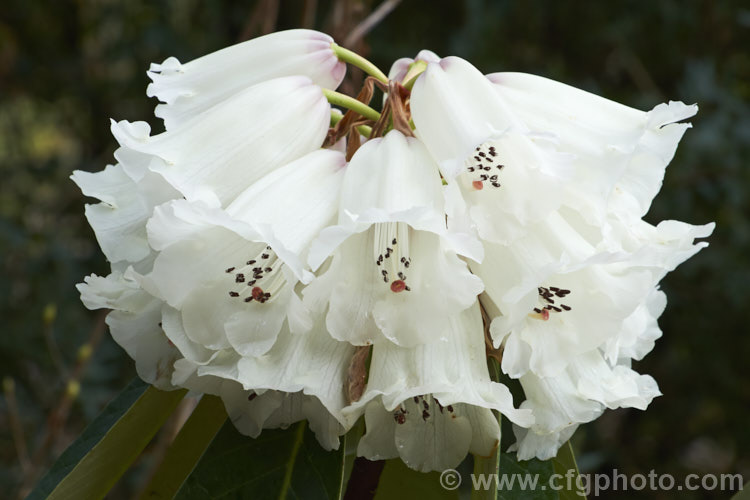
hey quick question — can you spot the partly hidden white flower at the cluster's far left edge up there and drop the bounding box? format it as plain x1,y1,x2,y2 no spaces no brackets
70,164,179,270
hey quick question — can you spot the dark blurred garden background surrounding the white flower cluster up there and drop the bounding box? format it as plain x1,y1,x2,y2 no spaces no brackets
0,0,750,499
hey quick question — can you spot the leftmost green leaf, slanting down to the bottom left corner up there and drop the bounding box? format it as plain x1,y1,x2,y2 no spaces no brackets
27,379,186,500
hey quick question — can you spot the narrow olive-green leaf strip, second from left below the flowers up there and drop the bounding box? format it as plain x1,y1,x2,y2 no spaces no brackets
141,394,227,499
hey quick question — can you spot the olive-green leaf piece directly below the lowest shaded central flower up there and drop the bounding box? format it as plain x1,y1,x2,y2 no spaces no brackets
375,458,459,500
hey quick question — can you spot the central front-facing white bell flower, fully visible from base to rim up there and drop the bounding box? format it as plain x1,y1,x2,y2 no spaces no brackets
303,130,482,345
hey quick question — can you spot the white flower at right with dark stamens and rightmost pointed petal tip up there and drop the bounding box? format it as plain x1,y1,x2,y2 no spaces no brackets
478,195,714,378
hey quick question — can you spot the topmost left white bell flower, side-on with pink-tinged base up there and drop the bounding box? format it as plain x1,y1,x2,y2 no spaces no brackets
146,29,346,130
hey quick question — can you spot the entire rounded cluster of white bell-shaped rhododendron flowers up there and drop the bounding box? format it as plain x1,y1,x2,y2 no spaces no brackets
72,30,714,471
